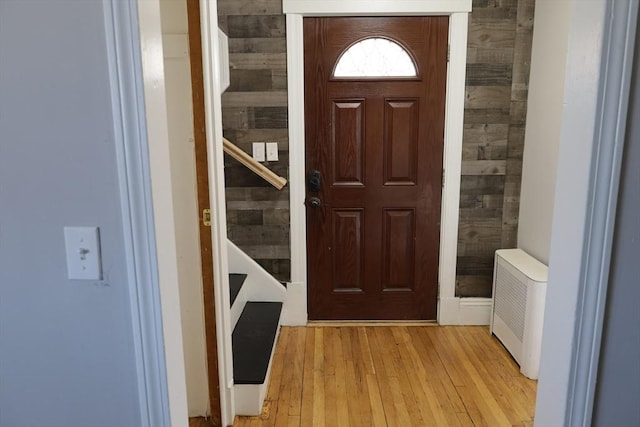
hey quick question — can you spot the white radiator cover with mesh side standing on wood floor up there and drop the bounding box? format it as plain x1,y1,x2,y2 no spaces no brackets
491,249,547,379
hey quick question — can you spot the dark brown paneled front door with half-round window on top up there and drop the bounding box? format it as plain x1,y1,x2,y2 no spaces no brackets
304,17,448,320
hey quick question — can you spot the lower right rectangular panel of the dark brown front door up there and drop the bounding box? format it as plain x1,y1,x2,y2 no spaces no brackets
382,209,416,292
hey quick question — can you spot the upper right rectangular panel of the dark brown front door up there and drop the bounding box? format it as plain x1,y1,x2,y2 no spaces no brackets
383,99,420,185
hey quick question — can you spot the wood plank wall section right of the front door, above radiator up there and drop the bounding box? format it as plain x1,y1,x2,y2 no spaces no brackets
456,0,535,297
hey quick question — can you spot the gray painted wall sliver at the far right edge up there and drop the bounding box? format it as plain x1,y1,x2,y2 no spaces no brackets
593,25,640,427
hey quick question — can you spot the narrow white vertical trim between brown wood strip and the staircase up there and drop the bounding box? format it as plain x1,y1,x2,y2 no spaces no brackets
200,0,235,425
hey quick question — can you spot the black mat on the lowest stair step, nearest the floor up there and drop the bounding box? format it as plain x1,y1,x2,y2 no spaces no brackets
232,302,282,384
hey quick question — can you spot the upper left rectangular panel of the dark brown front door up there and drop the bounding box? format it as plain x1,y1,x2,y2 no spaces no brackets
330,99,364,185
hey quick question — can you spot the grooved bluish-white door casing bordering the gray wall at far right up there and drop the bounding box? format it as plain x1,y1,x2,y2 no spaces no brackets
567,1,638,425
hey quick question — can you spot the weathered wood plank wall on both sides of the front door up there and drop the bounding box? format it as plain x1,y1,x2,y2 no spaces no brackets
218,0,534,296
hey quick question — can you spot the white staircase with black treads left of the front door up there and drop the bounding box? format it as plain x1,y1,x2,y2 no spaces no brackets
228,242,286,415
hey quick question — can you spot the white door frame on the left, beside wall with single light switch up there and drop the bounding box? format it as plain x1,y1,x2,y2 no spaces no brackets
103,0,187,427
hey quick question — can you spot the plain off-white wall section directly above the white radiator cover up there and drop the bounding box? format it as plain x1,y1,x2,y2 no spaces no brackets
518,1,572,264
